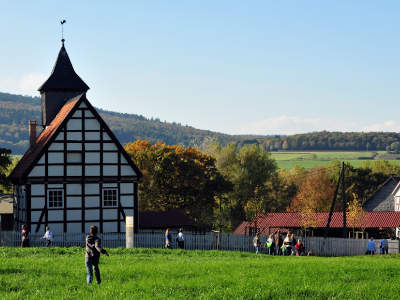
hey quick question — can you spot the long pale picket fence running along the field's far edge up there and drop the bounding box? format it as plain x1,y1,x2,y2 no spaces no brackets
0,231,399,256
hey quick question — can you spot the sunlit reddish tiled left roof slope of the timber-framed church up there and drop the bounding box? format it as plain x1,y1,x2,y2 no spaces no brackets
10,95,82,182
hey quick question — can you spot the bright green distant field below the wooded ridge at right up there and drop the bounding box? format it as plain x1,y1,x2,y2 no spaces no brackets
271,151,400,169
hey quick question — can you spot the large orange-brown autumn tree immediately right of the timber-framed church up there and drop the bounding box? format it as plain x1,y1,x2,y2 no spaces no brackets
125,140,231,224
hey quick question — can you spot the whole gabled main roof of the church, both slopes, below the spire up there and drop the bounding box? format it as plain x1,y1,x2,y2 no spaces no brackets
9,94,142,183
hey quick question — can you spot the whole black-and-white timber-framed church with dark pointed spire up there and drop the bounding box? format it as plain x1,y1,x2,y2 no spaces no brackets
10,40,142,233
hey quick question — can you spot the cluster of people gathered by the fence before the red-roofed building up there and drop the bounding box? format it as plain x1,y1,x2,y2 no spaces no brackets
253,230,306,256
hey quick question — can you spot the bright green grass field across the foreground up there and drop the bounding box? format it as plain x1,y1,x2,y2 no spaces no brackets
0,248,400,299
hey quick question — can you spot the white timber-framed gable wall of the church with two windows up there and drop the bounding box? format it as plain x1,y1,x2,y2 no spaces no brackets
14,95,140,233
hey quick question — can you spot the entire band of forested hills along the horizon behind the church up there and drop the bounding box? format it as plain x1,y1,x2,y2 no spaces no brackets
0,93,400,154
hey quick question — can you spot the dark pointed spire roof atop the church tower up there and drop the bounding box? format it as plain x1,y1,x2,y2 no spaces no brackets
38,43,89,93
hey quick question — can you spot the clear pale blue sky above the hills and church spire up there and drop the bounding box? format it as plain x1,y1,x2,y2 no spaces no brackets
0,0,400,134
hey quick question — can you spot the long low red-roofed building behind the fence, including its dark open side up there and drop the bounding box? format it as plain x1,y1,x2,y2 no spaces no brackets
234,211,400,238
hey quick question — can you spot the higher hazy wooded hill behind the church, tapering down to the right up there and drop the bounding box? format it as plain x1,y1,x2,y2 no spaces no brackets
0,93,260,154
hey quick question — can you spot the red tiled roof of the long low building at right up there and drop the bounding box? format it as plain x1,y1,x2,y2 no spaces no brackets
234,211,400,234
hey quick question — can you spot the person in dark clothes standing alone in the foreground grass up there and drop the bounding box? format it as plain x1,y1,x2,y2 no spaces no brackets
85,225,109,284
